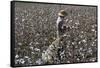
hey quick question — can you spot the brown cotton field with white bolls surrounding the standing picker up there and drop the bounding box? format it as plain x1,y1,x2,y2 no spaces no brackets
14,2,98,66
